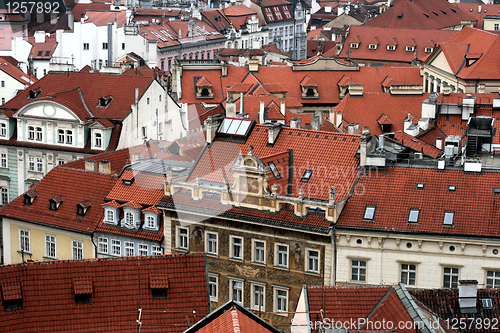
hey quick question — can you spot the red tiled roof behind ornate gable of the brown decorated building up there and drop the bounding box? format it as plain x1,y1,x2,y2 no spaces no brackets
189,125,359,200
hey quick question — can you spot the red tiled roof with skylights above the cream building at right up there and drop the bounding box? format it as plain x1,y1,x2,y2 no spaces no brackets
338,167,500,237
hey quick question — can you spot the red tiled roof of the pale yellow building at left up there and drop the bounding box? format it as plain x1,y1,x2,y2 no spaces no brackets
0,167,118,234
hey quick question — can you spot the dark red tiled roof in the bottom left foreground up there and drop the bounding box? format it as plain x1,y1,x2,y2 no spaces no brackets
0,253,209,333
